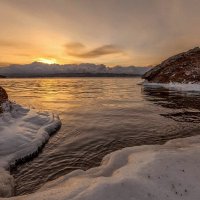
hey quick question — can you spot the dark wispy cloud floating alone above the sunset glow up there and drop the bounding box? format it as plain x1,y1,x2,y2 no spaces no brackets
65,42,123,58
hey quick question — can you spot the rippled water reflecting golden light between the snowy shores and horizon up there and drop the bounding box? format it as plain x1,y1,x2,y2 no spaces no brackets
1,78,200,195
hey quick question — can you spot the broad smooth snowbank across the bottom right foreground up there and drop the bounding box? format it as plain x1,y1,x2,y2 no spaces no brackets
5,136,200,200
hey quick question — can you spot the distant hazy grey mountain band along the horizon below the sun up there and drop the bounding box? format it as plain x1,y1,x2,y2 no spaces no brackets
0,62,150,77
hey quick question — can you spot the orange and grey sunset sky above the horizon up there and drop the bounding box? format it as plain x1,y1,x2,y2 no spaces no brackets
0,0,200,66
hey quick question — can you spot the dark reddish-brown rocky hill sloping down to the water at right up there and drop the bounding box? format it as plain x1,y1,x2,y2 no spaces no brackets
142,47,200,83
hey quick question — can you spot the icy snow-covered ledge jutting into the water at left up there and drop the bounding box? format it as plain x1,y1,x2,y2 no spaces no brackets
0,102,61,197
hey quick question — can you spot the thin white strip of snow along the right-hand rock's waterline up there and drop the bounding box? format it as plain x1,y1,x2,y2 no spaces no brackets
143,81,200,92
